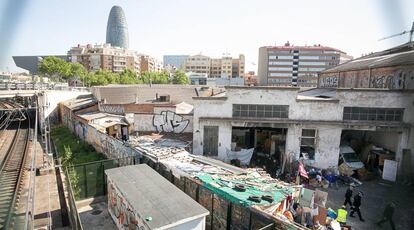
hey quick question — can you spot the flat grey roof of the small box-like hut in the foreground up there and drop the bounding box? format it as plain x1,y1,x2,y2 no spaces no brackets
105,164,209,229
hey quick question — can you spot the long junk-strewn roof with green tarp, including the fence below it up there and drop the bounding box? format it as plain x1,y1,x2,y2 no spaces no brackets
130,136,352,229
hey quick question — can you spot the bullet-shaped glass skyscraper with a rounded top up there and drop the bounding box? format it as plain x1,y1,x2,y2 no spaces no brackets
106,6,129,49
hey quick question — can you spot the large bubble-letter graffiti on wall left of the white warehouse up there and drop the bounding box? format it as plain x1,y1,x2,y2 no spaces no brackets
152,111,190,133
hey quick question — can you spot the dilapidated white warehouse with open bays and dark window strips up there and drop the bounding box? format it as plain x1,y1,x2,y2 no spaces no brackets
193,86,414,174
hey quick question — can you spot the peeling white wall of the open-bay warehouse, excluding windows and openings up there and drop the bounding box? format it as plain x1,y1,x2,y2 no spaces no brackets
193,87,414,168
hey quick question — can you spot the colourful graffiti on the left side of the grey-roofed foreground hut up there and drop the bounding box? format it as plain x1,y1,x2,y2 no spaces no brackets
108,179,148,230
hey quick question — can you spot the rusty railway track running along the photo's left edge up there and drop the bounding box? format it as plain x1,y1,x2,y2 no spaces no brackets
0,120,30,229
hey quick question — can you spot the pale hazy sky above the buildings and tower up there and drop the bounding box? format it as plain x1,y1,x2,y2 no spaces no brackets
0,0,414,72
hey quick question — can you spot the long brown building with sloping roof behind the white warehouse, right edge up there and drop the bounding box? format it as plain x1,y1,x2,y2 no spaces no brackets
318,42,414,90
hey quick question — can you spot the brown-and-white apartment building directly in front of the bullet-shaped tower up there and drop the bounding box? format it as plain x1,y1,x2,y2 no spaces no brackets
68,44,140,73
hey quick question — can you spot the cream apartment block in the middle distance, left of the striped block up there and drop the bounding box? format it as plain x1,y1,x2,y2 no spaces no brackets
184,54,245,78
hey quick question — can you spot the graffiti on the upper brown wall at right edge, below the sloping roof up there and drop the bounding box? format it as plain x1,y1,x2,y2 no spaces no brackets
371,70,414,89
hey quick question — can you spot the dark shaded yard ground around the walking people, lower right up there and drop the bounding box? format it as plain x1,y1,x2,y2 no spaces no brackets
321,179,414,230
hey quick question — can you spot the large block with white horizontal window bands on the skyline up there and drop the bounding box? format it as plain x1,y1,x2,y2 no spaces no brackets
258,42,352,87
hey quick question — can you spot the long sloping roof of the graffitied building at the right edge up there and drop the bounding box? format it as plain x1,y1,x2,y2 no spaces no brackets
322,42,414,73
